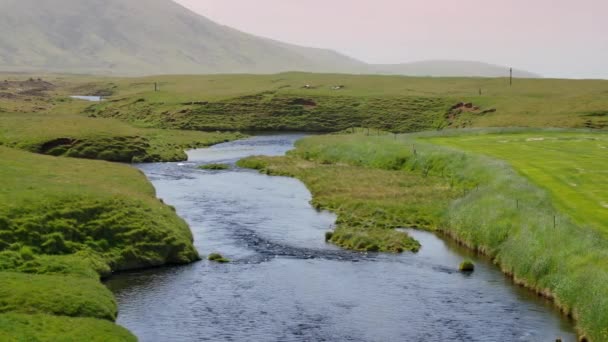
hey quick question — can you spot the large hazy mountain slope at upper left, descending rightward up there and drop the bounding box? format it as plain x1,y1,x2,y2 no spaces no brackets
0,0,536,76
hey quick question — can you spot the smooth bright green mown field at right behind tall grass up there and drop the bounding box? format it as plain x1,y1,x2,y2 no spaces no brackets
431,132,608,234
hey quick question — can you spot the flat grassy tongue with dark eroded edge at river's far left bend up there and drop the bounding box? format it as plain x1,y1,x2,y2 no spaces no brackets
0,113,243,163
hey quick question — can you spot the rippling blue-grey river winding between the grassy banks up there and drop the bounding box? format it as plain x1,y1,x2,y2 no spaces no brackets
107,134,575,342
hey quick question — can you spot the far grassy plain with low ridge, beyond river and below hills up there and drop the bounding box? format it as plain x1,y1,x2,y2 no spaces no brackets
69,73,608,132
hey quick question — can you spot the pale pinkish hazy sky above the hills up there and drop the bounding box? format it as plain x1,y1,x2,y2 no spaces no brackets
176,0,608,78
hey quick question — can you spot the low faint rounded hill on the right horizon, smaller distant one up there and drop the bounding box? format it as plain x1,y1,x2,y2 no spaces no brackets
372,60,540,78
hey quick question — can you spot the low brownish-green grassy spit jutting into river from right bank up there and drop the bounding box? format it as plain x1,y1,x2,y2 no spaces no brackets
239,151,456,252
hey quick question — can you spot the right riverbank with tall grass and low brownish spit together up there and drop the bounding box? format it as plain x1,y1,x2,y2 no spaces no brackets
241,132,608,341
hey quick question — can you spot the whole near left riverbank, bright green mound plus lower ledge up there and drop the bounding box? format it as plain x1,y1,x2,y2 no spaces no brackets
0,146,199,340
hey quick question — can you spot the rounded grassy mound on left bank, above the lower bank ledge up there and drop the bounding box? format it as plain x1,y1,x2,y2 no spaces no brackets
0,147,197,270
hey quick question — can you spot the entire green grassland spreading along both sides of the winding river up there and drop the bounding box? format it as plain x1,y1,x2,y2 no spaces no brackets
0,73,608,341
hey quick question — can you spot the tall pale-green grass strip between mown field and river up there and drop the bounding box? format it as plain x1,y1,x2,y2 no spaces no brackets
245,134,608,341
